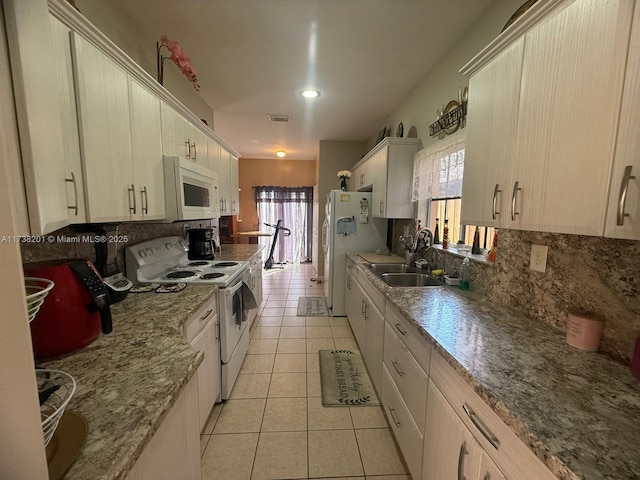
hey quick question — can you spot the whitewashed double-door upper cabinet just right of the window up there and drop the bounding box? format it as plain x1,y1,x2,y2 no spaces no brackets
462,0,633,235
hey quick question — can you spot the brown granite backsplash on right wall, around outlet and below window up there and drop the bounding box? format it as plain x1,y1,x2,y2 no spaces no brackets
392,220,640,360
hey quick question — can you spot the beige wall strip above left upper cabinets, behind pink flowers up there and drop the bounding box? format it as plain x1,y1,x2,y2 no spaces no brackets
76,0,214,128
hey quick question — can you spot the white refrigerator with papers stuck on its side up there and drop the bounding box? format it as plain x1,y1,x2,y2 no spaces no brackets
322,190,387,317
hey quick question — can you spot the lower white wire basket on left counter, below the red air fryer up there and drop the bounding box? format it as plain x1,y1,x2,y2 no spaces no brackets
36,369,76,446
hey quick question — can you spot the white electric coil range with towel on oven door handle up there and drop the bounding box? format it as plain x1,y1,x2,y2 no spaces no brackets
125,237,258,400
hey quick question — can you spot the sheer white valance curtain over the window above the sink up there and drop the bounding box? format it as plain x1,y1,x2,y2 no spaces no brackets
411,130,466,202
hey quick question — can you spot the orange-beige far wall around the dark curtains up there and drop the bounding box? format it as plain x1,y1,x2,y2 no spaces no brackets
238,158,316,232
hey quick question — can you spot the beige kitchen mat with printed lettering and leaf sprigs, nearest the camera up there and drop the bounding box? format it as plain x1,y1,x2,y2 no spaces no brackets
318,350,380,407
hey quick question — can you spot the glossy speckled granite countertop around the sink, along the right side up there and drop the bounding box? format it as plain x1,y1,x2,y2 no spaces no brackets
349,254,640,480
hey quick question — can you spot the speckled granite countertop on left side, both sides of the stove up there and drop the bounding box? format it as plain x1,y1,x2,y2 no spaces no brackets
40,245,260,480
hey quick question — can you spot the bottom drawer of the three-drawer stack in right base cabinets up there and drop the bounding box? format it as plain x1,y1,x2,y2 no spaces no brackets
382,365,424,478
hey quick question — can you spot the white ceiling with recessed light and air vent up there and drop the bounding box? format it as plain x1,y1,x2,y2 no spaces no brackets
116,0,494,160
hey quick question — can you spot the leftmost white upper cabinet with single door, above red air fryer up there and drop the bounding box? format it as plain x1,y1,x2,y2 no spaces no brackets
4,1,86,235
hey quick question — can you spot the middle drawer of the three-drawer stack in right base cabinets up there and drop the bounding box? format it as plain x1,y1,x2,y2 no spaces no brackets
384,323,429,435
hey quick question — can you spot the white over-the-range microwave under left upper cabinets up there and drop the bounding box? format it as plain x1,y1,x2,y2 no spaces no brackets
163,157,220,222
